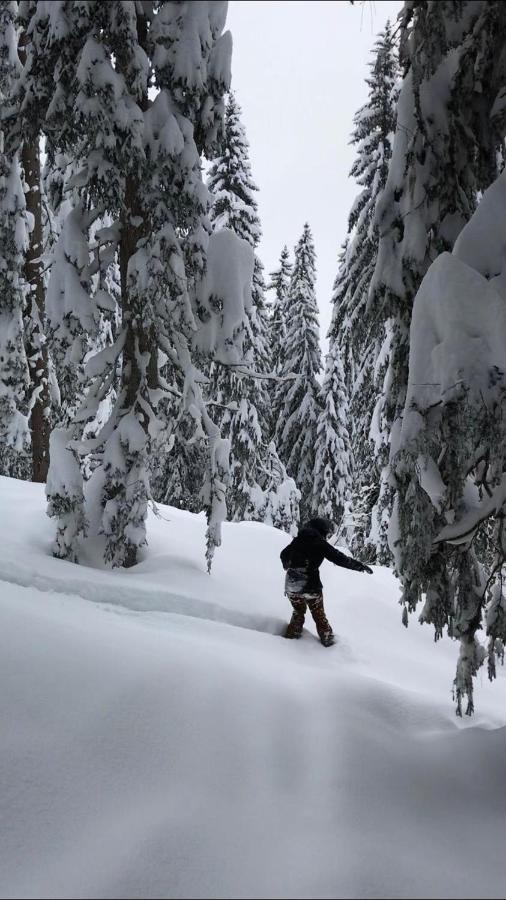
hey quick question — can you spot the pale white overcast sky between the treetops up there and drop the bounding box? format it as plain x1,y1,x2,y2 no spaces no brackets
227,0,402,349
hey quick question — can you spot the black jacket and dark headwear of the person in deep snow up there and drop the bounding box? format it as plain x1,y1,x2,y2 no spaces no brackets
280,523,366,594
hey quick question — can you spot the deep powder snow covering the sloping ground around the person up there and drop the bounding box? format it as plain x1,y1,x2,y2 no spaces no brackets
0,478,506,898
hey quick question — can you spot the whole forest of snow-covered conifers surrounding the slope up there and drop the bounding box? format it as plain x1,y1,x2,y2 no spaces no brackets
0,0,506,714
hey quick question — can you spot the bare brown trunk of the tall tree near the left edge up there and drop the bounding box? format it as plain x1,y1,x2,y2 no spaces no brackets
19,32,51,482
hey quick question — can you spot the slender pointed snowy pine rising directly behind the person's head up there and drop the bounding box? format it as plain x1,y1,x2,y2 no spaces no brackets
275,223,322,517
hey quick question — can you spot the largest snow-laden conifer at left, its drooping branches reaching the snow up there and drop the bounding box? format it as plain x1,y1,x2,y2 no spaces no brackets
9,2,241,565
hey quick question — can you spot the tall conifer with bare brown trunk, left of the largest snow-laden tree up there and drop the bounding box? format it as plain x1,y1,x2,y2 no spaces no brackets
1,0,86,481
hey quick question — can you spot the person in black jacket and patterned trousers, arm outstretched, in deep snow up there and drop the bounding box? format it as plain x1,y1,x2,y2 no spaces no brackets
280,519,372,647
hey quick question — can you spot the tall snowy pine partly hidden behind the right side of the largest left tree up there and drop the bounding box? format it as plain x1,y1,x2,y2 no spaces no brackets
208,93,297,526
